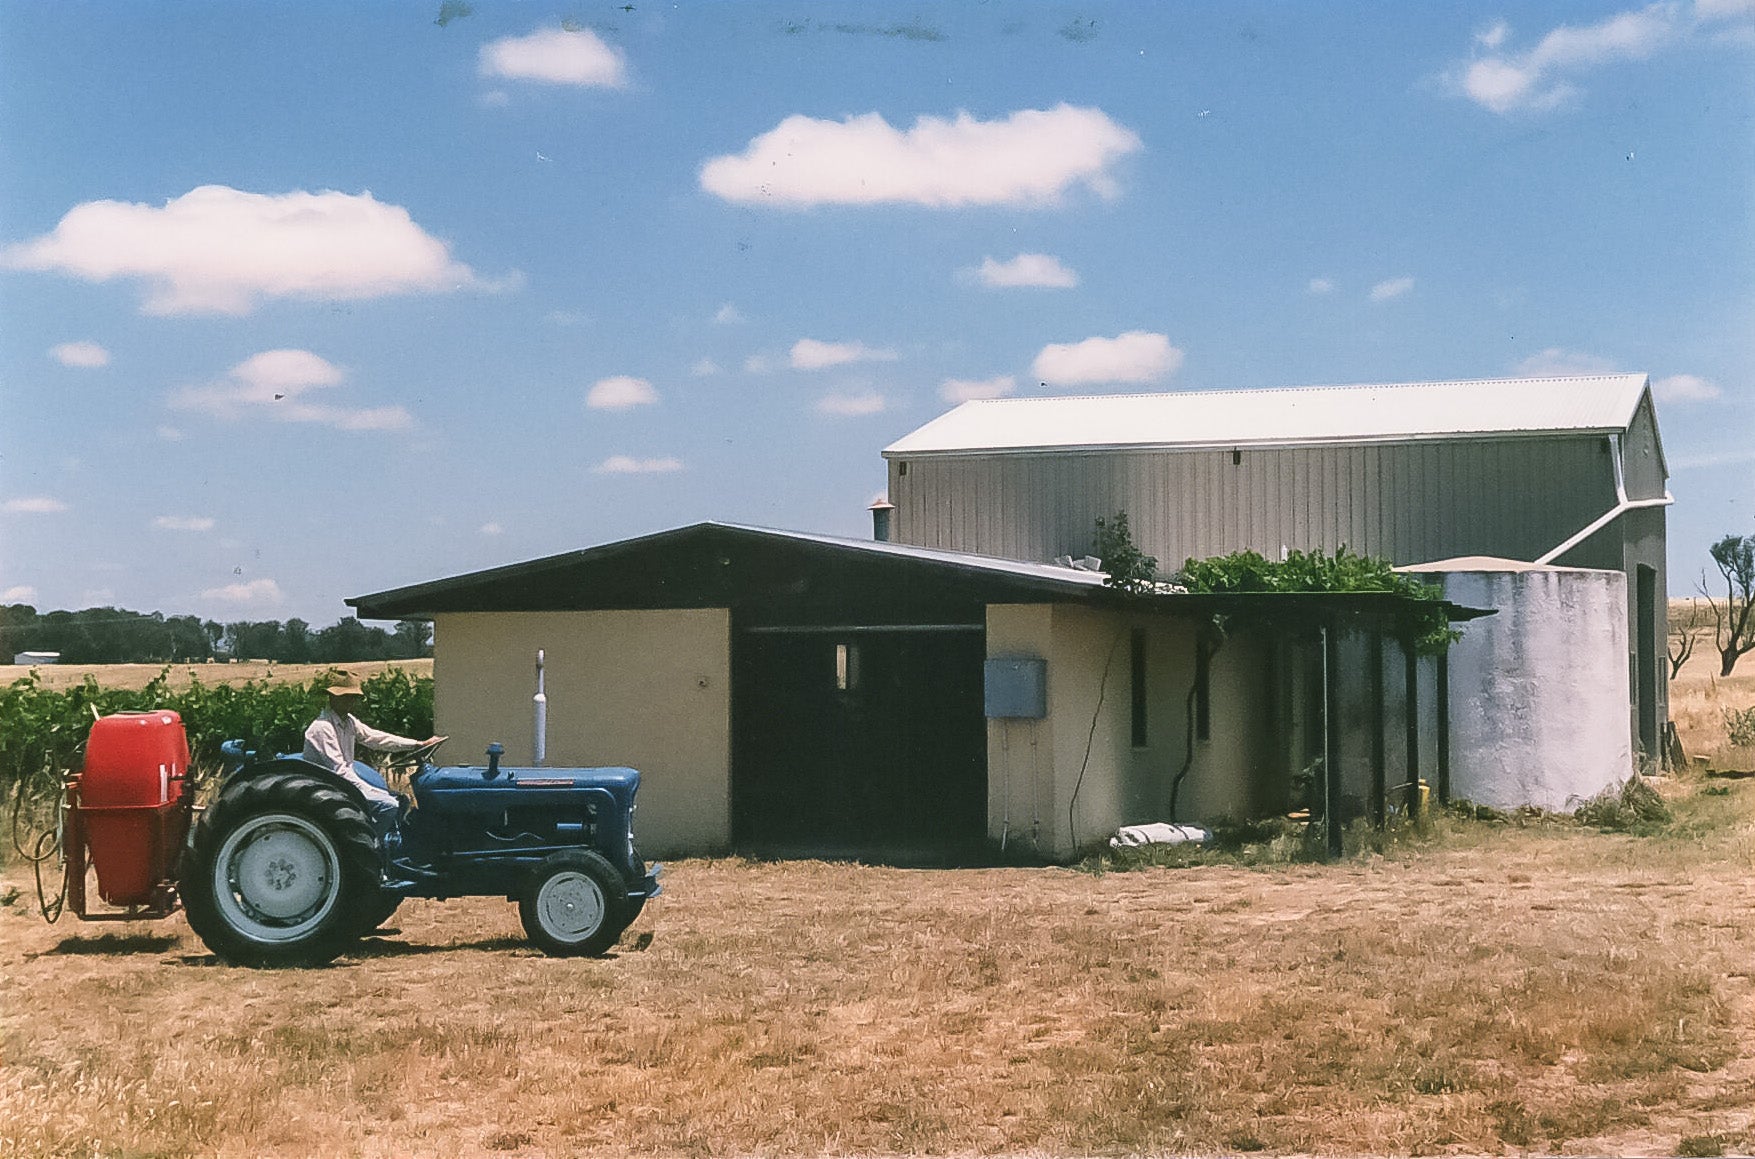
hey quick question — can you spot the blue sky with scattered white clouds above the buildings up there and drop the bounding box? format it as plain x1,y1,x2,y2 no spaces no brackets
0,0,1755,623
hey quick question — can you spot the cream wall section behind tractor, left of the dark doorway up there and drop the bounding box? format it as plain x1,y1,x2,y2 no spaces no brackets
433,608,732,857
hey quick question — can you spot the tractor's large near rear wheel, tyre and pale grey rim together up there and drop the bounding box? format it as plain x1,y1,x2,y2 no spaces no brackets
177,773,381,966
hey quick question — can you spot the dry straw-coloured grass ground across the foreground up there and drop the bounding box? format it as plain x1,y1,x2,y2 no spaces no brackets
0,776,1755,1155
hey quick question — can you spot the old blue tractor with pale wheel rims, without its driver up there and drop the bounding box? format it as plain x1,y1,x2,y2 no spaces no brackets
177,741,660,966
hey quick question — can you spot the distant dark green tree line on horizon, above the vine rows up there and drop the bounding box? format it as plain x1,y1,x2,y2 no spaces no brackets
0,604,432,664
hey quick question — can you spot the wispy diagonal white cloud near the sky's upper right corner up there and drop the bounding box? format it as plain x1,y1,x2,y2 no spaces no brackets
1460,0,1683,114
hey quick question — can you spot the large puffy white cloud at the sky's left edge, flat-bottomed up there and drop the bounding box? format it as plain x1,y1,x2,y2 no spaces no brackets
0,184,481,314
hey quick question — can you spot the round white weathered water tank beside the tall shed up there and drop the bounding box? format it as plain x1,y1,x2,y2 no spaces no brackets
1399,557,1634,811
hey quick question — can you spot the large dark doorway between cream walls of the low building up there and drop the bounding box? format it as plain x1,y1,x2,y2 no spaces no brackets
732,627,986,862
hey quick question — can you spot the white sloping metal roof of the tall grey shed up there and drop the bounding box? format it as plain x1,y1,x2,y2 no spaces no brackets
883,374,1648,457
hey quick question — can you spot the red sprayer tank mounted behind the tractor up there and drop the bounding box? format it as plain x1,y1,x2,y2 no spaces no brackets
77,709,190,906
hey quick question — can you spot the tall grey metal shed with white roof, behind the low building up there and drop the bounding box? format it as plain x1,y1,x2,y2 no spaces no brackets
883,374,1673,765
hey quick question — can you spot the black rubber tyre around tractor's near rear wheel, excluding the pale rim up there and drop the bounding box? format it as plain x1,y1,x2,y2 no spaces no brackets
177,773,381,968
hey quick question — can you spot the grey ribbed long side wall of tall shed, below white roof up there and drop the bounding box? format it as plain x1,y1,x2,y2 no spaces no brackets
890,436,1614,567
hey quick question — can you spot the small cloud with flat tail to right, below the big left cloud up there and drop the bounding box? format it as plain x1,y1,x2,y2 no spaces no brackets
167,349,414,430
